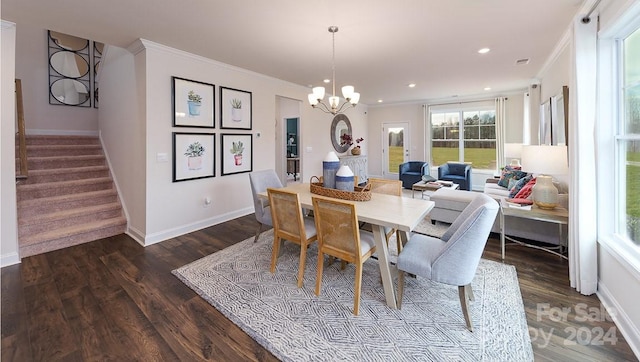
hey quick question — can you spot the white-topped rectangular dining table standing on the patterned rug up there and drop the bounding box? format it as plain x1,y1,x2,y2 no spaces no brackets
258,183,435,309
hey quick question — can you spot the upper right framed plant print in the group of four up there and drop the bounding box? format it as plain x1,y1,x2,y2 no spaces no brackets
220,87,252,129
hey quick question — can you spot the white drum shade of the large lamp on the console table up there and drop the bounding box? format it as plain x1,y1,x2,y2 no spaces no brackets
521,145,569,175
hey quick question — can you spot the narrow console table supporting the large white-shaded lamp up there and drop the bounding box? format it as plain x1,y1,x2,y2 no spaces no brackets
500,199,569,260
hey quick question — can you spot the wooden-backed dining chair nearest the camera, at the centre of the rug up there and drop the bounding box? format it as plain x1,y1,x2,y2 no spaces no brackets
312,197,376,315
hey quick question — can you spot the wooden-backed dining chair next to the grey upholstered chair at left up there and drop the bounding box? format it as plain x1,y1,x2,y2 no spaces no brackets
267,188,318,288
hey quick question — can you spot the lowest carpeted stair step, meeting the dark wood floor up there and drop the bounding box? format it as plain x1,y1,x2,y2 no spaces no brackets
20,217,127,258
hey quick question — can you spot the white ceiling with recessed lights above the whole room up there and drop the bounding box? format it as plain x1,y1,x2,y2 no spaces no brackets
1,0,589,104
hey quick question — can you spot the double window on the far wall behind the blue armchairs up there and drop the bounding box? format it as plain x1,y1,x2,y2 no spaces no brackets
431,106,497,170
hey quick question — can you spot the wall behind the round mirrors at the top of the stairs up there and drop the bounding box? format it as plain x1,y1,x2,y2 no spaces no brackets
15,24,98,135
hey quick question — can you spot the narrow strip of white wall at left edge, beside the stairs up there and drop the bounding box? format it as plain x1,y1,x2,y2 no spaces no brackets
0,21,20,267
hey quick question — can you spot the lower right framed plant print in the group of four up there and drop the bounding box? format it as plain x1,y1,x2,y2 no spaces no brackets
220,133,253,176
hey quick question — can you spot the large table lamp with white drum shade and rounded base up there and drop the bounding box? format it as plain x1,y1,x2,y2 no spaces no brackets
522,145,569,210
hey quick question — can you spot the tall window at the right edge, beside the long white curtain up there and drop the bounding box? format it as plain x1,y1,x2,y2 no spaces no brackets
615,29,640,245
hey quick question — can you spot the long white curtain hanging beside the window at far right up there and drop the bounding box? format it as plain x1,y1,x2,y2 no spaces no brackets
569,14,598,295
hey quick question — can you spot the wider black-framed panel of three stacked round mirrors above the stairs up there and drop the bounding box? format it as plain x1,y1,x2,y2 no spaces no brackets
48,30,91,107
